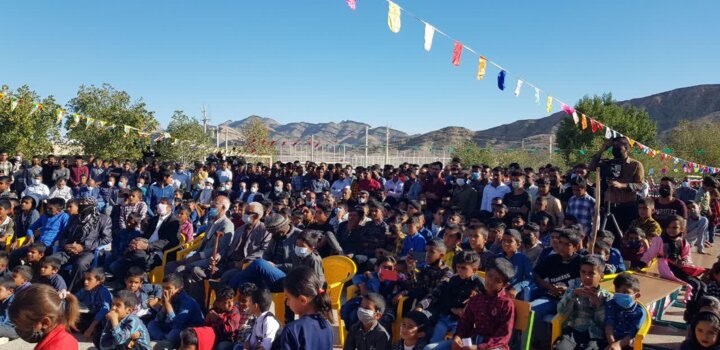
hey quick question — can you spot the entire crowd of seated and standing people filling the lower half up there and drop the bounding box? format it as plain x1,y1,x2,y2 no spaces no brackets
0,137,720,350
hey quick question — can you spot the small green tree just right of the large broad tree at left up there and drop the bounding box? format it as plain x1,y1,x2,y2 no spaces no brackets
154,111,211,162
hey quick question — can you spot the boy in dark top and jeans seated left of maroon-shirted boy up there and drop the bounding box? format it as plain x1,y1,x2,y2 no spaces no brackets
417,252,483,343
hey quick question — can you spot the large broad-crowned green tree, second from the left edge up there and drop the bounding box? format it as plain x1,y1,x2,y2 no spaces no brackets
66,84,158,159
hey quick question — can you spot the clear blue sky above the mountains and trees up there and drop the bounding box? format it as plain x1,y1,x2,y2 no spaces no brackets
0,0,720,133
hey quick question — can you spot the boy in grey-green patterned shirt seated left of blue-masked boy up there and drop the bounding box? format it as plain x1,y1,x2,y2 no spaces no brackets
554,256,612,350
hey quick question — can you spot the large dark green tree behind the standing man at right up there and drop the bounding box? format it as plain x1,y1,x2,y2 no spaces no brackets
557,94,656,164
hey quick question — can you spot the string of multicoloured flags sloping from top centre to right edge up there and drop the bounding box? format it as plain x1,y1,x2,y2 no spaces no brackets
346,0,720,173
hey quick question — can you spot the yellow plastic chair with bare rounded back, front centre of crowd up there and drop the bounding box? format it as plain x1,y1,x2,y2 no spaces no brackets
323,255,357,346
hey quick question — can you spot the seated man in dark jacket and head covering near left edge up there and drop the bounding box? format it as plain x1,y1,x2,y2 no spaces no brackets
52,197,112,292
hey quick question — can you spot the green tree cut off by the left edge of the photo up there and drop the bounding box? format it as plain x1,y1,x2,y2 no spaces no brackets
0,85,60,155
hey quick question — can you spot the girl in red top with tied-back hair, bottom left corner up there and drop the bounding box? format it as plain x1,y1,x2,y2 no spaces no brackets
10,284,80,350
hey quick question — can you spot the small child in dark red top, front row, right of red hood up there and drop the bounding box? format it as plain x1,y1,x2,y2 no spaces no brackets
205,287,244,350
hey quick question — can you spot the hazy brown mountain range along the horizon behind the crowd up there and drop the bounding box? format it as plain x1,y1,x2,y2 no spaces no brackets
214,84,720,147
